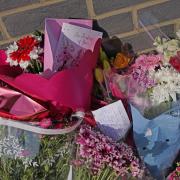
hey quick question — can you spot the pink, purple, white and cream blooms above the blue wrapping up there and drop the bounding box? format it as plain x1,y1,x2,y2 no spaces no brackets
114,29,180,119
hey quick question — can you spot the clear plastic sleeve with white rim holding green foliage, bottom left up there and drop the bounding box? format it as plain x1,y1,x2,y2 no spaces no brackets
0,118,81,180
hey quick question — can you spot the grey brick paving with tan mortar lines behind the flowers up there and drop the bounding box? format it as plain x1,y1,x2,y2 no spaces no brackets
0,0,180,52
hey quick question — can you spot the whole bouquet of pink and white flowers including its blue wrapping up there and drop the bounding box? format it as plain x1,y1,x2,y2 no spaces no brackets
109,31,180,179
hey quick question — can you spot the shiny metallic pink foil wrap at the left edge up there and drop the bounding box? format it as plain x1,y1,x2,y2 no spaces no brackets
0,87,49,120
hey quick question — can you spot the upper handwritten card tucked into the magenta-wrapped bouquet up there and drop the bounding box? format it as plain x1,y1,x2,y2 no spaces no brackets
53,23,102,70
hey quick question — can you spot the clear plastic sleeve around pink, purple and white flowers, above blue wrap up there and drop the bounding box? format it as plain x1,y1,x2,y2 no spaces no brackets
112,16,180,119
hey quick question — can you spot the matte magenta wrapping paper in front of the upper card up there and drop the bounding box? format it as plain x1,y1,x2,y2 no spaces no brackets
0,40,100,114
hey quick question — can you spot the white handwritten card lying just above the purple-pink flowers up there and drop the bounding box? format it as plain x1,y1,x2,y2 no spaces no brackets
92,100,131,141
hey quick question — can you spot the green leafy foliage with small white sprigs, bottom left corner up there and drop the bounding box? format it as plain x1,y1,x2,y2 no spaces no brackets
0,128,74,180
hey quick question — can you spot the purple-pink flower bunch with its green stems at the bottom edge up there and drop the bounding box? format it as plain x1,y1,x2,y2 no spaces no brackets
74,125,145,180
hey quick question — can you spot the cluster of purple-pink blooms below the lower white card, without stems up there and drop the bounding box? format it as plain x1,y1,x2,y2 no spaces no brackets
76,125,143,176
